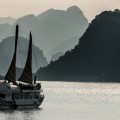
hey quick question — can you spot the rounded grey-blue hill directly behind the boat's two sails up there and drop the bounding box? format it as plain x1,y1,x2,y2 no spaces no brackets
0,37,48,76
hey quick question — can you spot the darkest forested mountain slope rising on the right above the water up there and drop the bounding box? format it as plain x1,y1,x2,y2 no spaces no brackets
39,10,120,82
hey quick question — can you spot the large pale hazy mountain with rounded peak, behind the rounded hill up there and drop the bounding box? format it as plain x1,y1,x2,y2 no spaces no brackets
0,6,88,61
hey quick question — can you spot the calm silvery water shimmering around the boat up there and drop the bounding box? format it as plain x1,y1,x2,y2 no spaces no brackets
0,82,120,120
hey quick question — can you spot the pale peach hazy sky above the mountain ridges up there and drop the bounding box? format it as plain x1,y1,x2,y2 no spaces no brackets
0,0,120,21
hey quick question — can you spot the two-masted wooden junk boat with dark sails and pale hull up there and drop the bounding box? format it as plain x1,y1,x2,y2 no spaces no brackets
0,25,44,110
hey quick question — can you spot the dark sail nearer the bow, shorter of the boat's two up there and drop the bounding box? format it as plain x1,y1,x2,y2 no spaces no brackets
18,32,33,84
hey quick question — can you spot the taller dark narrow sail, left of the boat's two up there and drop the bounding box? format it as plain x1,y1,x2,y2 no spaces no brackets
5,25,19,83
